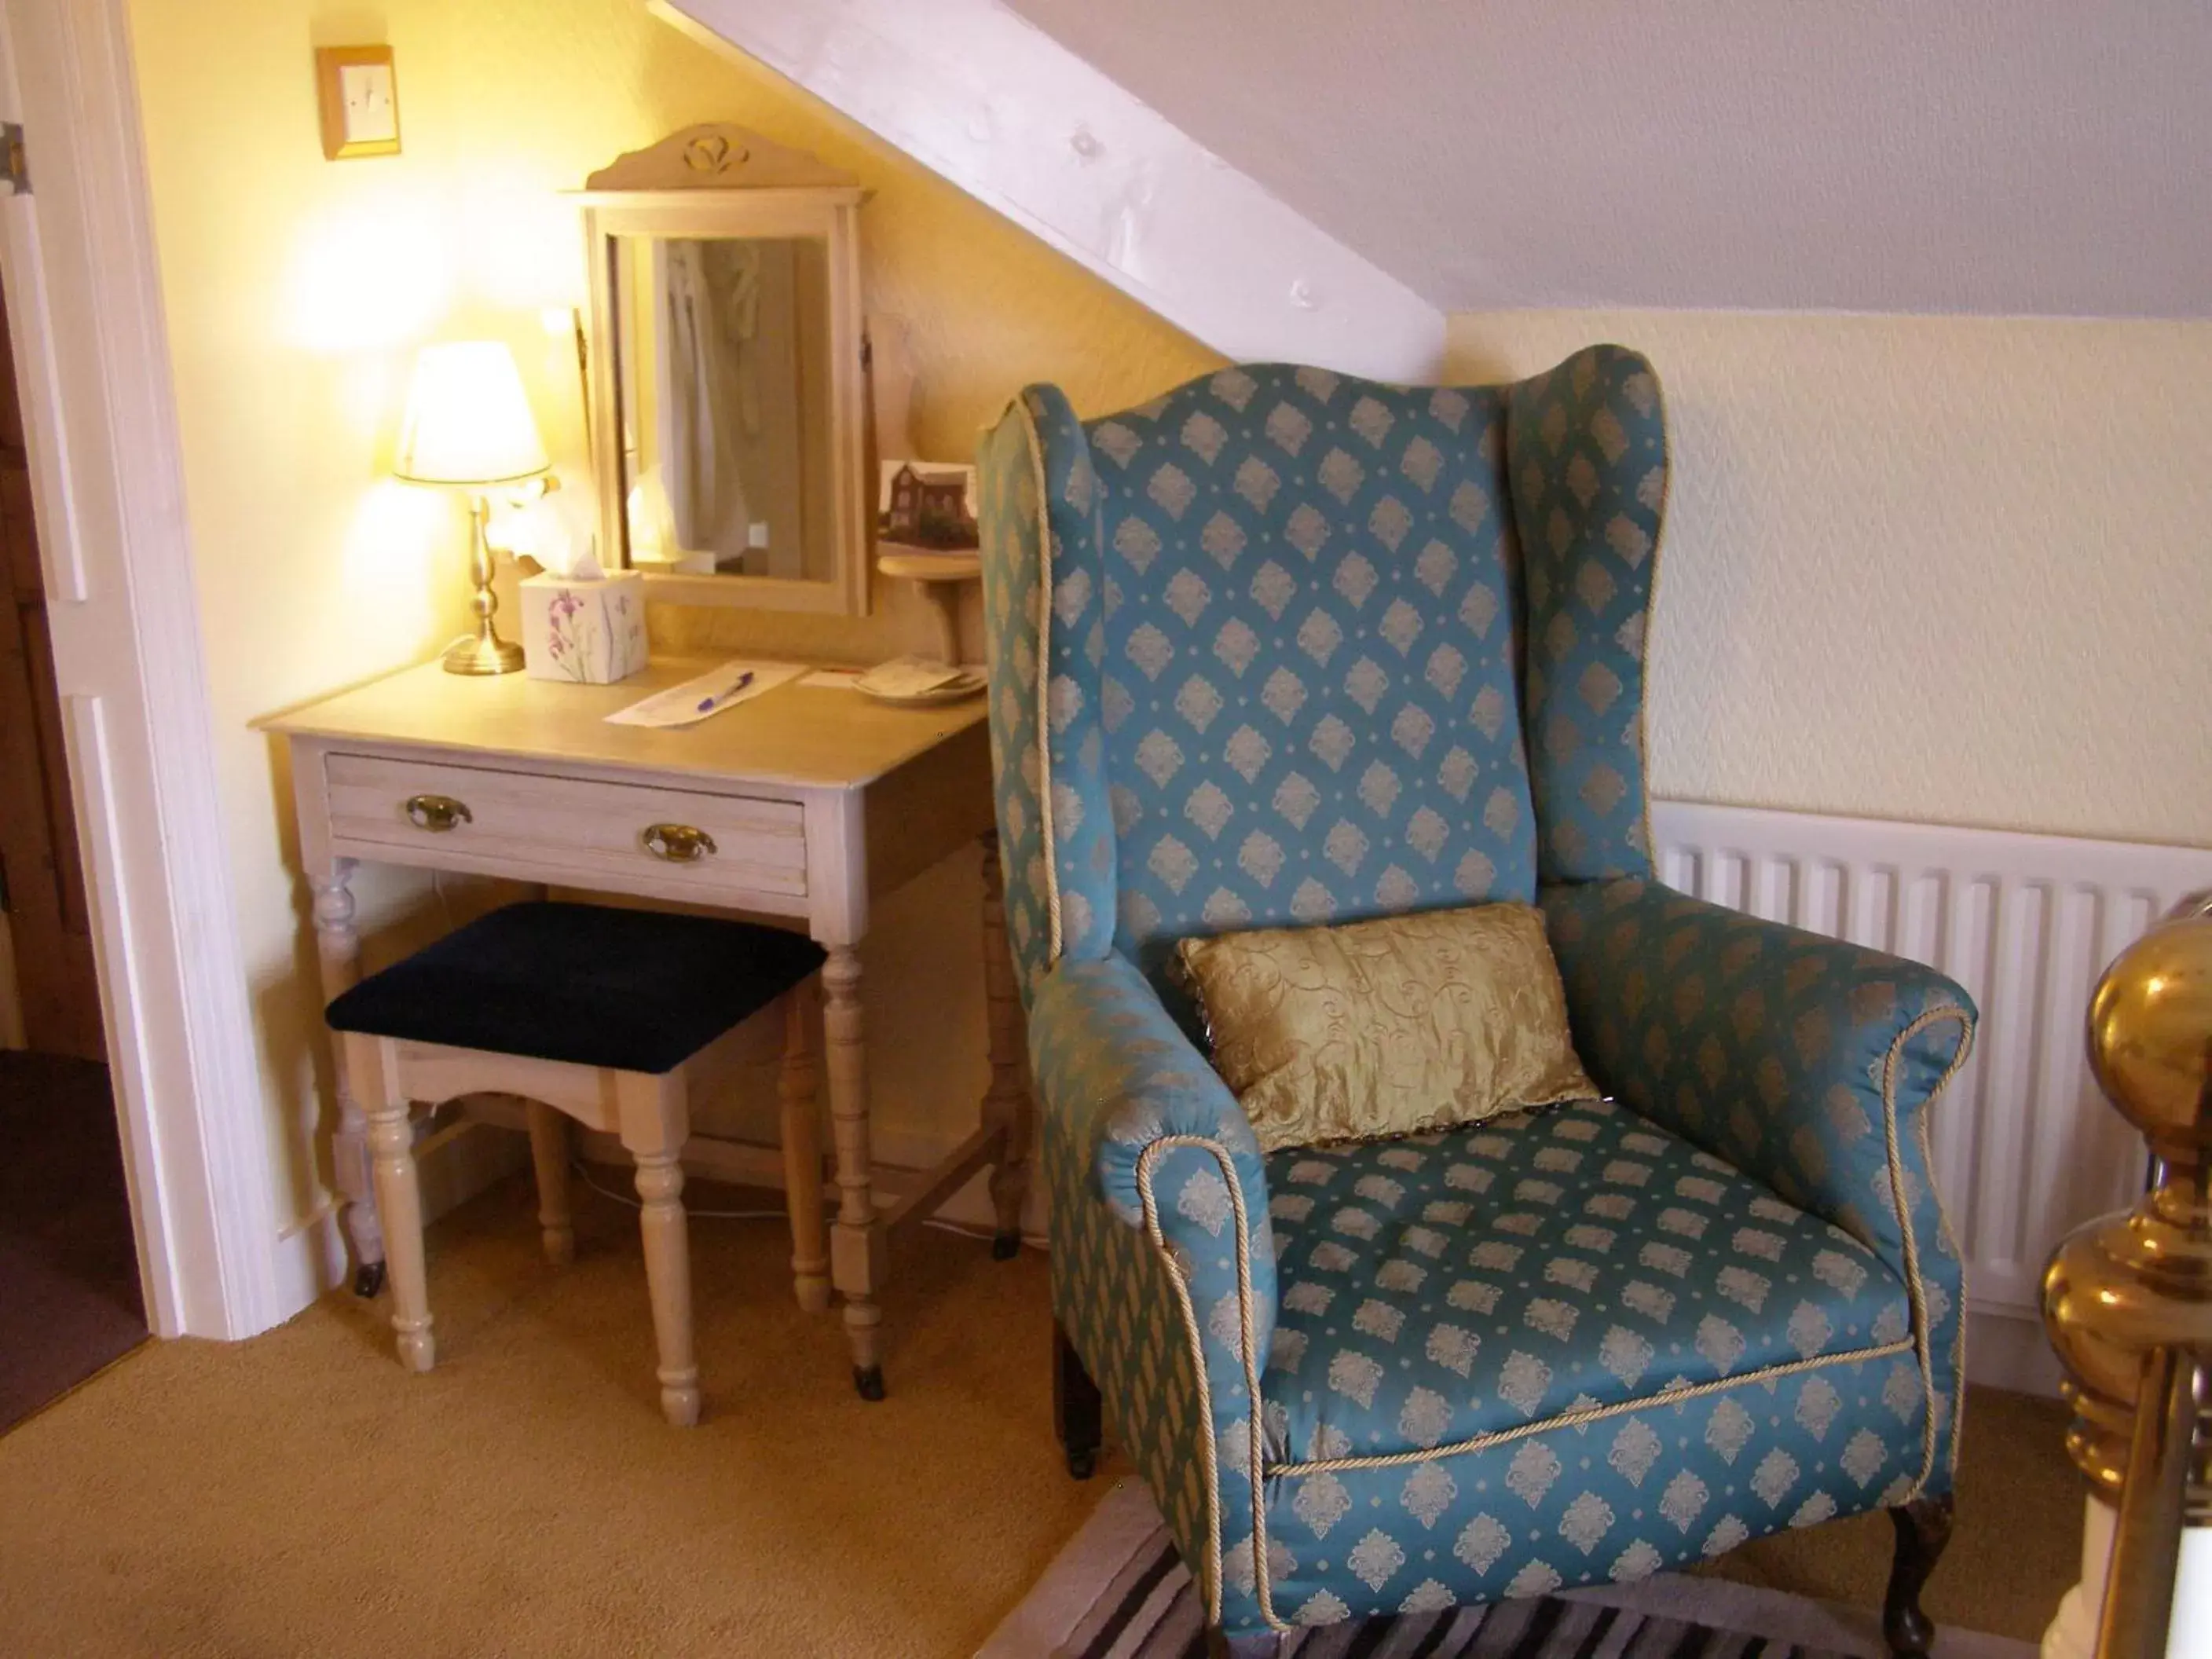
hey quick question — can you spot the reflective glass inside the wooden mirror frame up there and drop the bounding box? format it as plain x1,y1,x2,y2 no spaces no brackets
608,236,836,582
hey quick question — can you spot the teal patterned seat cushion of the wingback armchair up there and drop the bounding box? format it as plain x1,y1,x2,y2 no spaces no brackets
1261,1101,1925,1468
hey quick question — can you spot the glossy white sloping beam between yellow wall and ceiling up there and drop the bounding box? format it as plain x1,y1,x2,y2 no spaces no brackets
648,0,1445,380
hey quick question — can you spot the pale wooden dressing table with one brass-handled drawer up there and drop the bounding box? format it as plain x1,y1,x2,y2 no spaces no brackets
261,659,1031,1397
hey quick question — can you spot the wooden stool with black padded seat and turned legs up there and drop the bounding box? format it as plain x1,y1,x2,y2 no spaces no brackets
330,903,830,1426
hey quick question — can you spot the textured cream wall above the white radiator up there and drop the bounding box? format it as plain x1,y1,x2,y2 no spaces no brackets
1447,312,2212,845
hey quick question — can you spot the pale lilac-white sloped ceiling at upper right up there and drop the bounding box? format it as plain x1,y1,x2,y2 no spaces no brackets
1009,0,2212,317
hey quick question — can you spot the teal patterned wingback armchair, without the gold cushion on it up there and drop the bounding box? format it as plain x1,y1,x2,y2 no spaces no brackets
982,345,1976,1653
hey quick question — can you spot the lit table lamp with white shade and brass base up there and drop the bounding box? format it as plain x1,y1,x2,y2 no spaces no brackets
391,341,551,675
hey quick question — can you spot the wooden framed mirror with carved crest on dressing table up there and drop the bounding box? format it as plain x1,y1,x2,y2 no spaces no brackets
577,124,873,615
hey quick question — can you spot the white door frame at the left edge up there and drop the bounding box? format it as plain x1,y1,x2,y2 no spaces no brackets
0,0,285,1336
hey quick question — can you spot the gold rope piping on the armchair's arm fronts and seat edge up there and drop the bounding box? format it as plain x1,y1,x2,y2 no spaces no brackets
1137,1004,1973,1630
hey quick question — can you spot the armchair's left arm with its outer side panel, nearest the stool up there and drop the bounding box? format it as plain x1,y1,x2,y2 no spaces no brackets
1028,956,1276,1617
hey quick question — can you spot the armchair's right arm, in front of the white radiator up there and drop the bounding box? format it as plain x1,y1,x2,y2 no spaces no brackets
1542,881,1976,1496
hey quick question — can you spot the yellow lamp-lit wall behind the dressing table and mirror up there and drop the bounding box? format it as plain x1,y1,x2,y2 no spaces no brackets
130,0,1214,1217
